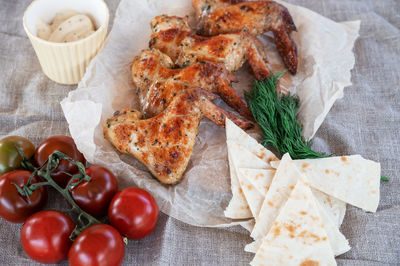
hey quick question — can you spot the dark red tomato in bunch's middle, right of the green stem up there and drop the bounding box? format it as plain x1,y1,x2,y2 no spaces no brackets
71,166,118,217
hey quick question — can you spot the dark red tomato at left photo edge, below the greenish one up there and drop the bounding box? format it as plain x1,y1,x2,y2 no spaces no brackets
0,170,47,223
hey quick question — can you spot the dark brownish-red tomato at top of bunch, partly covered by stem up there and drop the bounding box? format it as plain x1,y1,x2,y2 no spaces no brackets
34,136,86,187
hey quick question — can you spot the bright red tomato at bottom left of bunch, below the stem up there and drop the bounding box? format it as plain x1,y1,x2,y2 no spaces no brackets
21,210,75,263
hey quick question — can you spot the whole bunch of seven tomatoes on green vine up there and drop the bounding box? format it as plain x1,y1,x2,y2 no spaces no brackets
0,136,159,266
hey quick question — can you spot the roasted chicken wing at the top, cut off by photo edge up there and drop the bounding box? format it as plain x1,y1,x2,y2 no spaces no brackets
192,0,297,74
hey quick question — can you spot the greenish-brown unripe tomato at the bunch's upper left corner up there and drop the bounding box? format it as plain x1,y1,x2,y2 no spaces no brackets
0,136,35,175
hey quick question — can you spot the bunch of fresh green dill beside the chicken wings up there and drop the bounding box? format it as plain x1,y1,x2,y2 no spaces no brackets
246,73,329,159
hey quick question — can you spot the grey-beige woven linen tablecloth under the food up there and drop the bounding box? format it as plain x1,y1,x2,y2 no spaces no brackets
0,0,400,265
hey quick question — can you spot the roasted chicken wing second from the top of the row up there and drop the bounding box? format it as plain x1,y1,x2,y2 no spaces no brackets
149,15,270,80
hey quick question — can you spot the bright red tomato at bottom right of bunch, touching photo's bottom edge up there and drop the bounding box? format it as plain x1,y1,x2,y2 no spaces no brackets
68,224,125,266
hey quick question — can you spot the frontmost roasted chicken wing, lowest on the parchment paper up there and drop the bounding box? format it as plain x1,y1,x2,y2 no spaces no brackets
103,88,244,184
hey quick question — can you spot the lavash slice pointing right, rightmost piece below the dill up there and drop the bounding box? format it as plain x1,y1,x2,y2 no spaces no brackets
295,155,381,212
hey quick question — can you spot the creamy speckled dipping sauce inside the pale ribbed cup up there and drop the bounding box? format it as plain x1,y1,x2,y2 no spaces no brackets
36,9,96,42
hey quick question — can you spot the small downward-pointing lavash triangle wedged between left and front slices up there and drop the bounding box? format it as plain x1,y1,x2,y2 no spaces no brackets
238,168,275,217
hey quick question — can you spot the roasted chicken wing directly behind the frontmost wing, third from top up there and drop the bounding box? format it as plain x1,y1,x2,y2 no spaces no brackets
131,49,252,120
